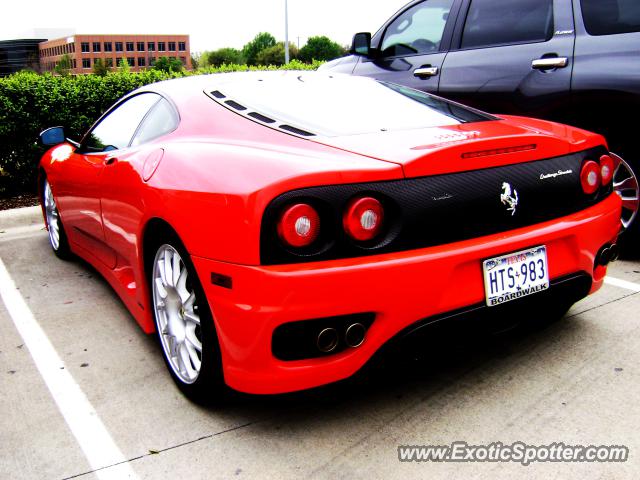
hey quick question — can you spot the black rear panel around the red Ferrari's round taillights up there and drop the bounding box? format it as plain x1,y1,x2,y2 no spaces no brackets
260,147,612,264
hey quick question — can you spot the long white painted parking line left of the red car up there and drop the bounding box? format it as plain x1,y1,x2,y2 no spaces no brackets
0,259,138,480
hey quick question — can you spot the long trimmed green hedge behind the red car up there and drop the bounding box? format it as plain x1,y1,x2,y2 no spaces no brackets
0,61,320,197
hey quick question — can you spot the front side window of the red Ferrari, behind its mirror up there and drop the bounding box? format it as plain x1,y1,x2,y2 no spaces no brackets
81,93,161,152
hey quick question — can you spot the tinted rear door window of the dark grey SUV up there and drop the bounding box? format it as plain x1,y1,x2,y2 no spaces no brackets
461,0,556,48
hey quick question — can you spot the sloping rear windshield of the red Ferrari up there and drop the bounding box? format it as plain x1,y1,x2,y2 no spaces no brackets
209,72,495,137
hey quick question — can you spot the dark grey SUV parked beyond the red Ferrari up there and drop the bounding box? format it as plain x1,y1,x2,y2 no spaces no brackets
321,0,640,229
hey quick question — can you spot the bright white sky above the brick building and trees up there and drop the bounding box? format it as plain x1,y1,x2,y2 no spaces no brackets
0,0,409,52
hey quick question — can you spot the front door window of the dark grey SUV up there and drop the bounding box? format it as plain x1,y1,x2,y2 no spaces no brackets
380,0,453,57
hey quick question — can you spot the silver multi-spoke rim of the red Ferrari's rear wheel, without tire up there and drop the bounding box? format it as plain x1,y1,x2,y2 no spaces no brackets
152,244,202,384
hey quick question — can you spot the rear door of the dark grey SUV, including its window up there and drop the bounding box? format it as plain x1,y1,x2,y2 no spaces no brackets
439,0,575,120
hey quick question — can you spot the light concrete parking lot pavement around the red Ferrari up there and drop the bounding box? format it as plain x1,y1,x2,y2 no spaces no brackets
0,209,640,479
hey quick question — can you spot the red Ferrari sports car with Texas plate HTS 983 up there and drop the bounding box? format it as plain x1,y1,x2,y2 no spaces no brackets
40,72,621,398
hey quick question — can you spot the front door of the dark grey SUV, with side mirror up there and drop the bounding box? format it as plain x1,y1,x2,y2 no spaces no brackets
353,0,461,93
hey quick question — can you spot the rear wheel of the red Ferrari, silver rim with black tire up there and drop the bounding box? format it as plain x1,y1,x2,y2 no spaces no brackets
151,241,221,401
